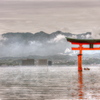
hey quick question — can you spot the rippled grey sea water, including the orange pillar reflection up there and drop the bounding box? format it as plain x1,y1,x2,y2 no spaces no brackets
0,65,100,100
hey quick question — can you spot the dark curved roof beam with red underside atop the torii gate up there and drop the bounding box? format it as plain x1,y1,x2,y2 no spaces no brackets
66,37,100,44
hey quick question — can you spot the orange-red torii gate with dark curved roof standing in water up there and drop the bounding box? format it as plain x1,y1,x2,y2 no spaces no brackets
66,38,100,71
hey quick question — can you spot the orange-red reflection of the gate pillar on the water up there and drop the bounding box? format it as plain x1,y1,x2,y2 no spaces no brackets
78,72,83,99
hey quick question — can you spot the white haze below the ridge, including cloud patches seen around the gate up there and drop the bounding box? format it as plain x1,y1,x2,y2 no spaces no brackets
0,33,99,57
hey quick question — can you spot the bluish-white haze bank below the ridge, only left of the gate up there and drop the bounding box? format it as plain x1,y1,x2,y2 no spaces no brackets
0,35,71,57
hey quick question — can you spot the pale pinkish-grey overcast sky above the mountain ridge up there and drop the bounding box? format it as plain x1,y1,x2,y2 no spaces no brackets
0,0,100,34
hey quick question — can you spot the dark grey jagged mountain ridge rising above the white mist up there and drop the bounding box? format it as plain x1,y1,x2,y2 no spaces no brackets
2,31,91,43
